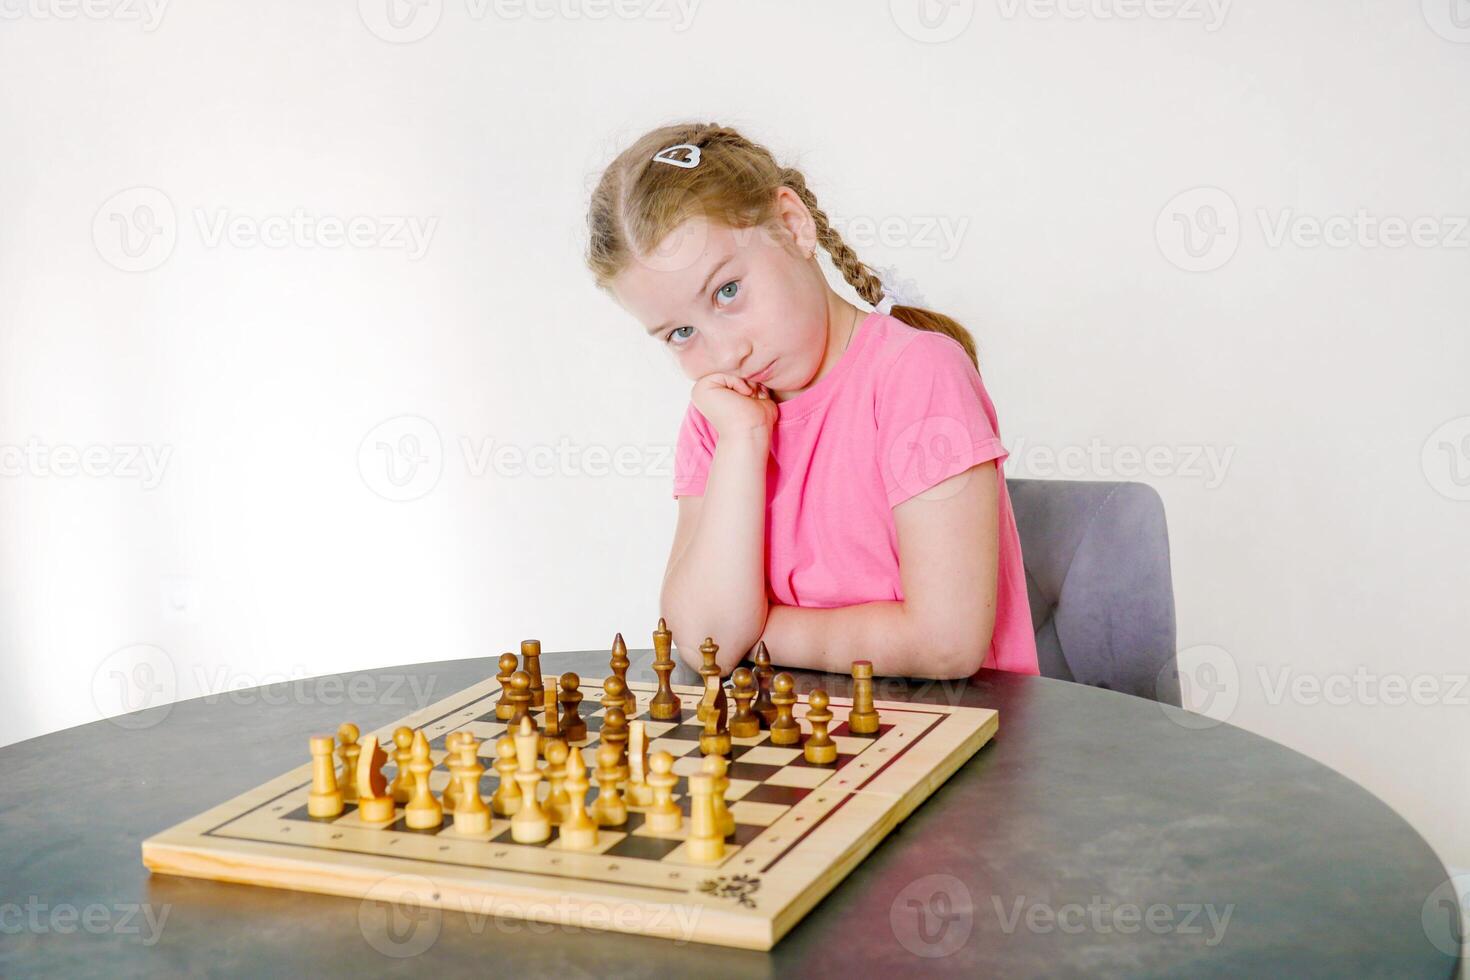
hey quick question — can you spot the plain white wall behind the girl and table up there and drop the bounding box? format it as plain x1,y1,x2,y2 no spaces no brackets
0,0,1470,867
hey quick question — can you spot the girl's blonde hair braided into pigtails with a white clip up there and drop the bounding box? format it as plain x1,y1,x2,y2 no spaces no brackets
587,122,979,369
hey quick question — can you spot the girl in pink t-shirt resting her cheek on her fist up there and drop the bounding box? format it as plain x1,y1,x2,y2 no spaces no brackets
587,123,1038,677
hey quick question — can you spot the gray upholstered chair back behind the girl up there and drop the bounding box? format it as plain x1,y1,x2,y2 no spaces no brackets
1005,479,1179,705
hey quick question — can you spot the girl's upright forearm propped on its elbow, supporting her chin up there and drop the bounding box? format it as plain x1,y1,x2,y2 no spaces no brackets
660,430,770,671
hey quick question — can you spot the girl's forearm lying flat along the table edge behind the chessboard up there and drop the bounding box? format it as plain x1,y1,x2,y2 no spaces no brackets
760,601,988,679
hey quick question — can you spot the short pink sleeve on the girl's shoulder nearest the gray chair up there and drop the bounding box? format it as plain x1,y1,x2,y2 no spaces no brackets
875,334,1010,507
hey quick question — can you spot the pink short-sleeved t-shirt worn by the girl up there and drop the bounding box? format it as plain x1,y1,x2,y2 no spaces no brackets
673,311,1039,674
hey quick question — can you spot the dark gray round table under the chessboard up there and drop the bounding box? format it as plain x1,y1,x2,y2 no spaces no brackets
0,651,1458,980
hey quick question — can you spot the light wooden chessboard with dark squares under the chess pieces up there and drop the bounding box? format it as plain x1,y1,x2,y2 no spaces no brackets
143,676,998,949
